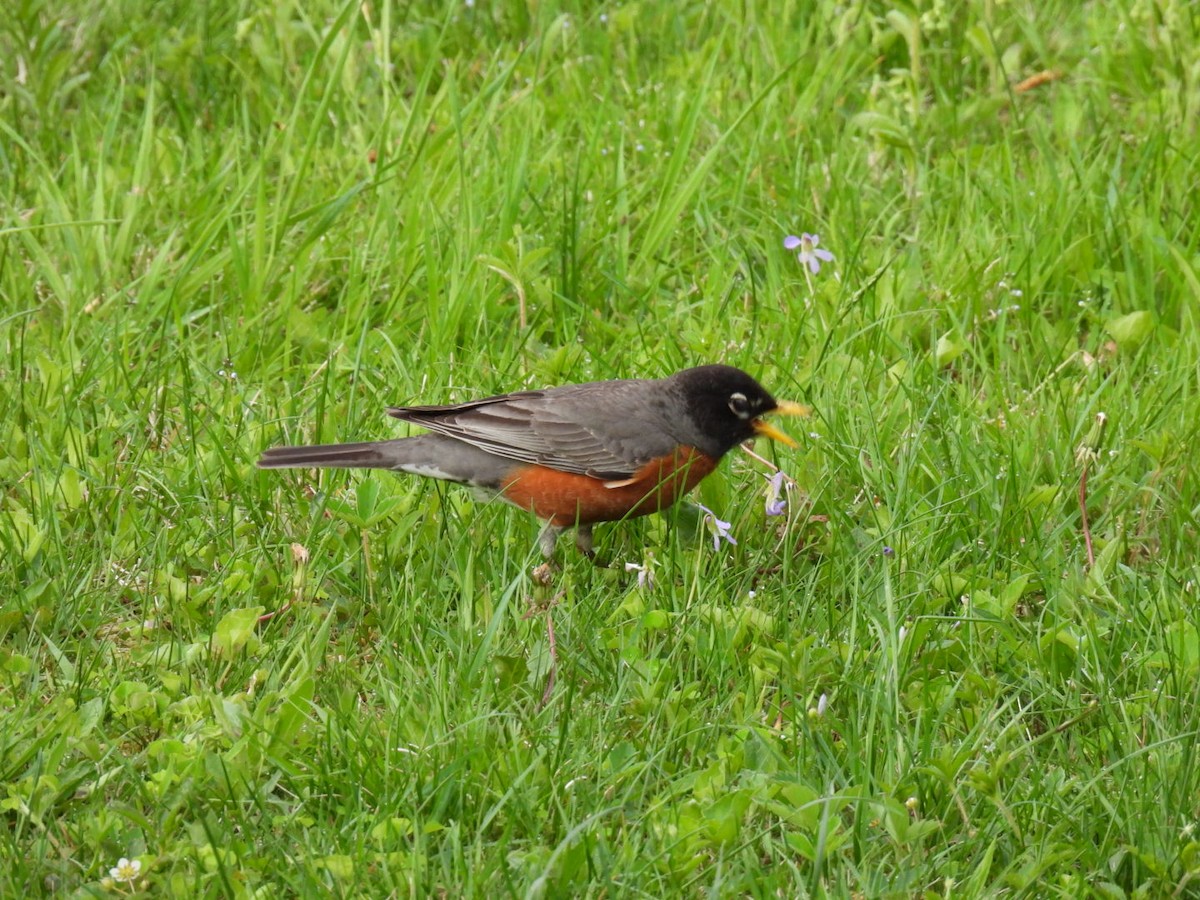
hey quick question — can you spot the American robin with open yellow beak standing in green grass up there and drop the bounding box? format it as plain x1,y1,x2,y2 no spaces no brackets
258,366,809,558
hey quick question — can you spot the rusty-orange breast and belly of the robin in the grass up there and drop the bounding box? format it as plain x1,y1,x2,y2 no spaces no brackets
500,446,716,527
